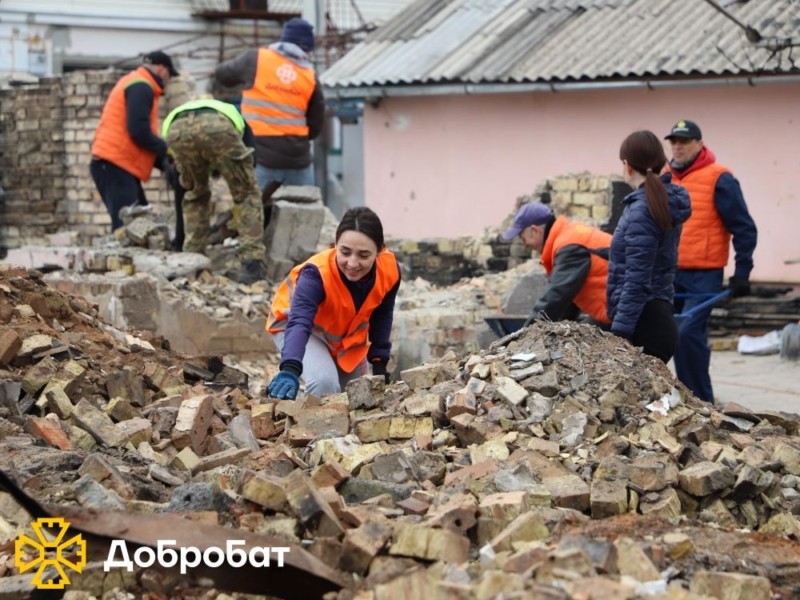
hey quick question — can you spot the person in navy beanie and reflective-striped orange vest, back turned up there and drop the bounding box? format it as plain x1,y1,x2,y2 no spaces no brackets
215,18,325,192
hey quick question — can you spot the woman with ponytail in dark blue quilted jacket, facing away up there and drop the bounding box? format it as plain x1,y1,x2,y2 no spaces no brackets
606,131,692,363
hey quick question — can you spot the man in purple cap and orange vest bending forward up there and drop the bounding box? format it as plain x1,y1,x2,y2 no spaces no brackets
503,202,611,327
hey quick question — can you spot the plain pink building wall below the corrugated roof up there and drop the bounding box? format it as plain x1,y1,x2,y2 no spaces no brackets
364,83,800,283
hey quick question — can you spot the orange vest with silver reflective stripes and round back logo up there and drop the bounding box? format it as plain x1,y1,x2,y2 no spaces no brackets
242,48,316,136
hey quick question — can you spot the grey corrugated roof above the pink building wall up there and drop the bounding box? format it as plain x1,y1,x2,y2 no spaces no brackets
322,0,800,88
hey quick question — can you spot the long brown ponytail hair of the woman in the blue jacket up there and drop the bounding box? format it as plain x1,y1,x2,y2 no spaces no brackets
619,130,672,231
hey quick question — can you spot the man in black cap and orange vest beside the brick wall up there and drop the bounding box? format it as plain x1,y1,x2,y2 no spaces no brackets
89,51,178,230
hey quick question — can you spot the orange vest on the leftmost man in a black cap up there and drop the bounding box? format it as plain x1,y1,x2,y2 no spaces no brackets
92,67,164,181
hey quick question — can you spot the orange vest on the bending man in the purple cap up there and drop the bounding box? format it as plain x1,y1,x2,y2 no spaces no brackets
541,217,611,323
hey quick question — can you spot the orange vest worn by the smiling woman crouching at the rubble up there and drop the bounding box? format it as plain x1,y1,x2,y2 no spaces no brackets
266,248,400,373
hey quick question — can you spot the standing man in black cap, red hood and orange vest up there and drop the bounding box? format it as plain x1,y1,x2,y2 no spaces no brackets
664,120,758,402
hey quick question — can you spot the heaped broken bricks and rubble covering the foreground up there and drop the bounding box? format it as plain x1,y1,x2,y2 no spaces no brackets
0,267,800,600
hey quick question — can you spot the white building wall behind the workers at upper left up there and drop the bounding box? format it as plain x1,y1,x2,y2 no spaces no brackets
0,0,280,87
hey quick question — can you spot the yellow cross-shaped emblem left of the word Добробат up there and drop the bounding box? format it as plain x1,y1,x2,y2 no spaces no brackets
14,517,86,590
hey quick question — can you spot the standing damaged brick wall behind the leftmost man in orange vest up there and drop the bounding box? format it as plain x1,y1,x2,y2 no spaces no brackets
0,70,178,249
